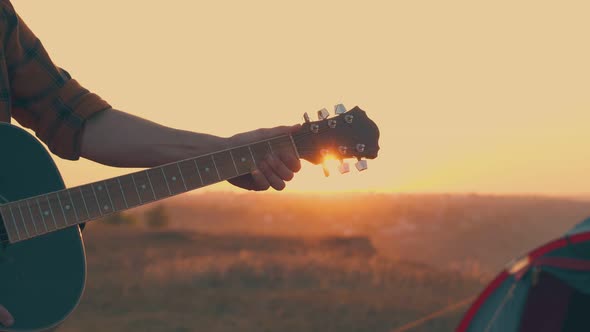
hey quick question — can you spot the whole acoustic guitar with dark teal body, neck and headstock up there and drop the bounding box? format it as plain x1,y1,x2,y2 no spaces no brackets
0,105,379,331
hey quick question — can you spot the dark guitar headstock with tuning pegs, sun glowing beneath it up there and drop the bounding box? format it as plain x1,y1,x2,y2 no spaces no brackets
293,104,379,176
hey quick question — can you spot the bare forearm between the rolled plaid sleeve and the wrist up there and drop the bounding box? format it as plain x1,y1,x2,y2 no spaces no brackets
81,110,228,168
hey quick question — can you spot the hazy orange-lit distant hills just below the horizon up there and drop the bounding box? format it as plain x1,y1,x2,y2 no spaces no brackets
118,193,590,275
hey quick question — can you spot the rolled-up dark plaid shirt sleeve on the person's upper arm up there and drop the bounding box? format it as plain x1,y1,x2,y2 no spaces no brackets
0,0,111,160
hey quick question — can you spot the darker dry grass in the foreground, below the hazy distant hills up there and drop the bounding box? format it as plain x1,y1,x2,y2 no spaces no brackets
61,225,481,331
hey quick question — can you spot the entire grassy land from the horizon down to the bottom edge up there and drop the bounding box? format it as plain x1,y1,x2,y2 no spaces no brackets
59,194,590,332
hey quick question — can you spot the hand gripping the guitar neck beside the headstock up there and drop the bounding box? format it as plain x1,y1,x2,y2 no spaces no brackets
228,125,301,190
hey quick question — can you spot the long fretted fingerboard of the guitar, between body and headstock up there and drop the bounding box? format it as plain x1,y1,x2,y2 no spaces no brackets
0,135,297,243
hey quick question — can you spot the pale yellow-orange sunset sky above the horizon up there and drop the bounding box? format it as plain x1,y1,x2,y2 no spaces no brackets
13,0,590,194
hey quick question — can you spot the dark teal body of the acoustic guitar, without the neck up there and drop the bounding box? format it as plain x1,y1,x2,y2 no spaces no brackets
0,123,86,331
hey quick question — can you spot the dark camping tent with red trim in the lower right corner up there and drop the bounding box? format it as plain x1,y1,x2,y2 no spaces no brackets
456,218,590,332
